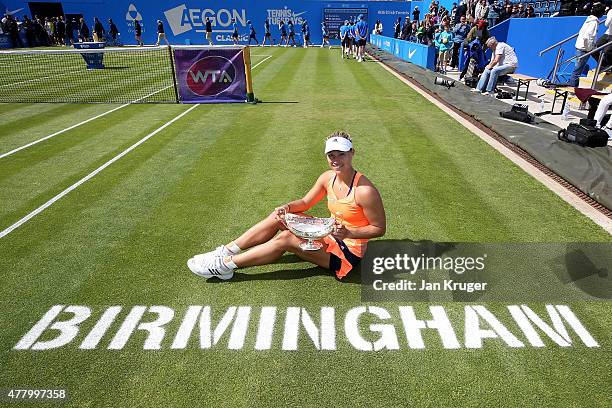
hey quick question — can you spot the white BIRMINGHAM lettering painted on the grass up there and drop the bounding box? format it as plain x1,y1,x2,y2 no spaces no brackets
13,305,600,351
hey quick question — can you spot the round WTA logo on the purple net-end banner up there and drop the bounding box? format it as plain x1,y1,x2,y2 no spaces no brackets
185,55,236,96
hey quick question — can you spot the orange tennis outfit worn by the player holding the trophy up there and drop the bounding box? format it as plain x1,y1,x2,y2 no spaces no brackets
323,172,370,279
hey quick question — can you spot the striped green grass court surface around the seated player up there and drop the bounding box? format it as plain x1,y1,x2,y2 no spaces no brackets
0,48,612,407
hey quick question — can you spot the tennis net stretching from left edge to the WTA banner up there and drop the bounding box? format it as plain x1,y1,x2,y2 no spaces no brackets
0,47,178,103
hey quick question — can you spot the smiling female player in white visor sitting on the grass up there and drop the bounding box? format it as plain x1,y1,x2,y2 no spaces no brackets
187,132,386,280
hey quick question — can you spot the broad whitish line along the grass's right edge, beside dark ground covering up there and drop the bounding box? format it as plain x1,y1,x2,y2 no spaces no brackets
375,60,612,234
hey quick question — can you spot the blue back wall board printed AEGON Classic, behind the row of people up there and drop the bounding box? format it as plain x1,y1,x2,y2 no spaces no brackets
2,0,411,45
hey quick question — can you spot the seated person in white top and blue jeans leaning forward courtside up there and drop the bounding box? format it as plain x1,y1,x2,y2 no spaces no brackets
471,37,518,95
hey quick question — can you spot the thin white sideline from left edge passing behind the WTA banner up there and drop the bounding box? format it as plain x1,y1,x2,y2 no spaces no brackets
0,55,272,238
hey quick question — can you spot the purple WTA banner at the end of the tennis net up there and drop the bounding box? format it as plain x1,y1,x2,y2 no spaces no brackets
174,47,247,103
